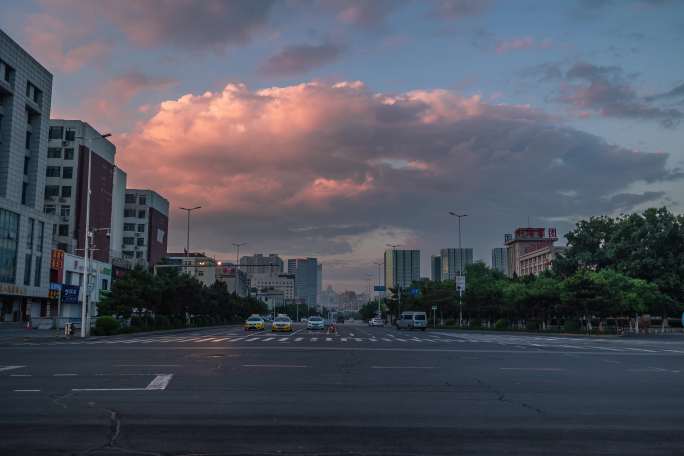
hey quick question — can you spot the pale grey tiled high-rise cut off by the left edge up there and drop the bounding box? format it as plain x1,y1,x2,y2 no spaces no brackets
0,30,57,321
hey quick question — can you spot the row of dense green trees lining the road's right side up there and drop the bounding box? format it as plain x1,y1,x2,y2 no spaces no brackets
362,208,684,330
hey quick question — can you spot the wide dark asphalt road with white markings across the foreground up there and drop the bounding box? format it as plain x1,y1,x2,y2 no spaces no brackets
0,325,684,455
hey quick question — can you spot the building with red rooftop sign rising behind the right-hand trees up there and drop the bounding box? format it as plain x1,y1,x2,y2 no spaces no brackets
504,228,558,277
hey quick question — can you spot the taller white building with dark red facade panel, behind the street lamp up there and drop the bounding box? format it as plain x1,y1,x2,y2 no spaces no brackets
45,119,126,262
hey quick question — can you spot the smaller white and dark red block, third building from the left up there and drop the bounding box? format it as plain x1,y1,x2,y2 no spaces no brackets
121,188,169,268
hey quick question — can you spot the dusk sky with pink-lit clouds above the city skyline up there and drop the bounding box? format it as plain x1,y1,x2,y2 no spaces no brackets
0,0,684,291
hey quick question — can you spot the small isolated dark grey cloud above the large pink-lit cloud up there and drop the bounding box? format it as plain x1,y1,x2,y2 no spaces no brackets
261,43,344,76
